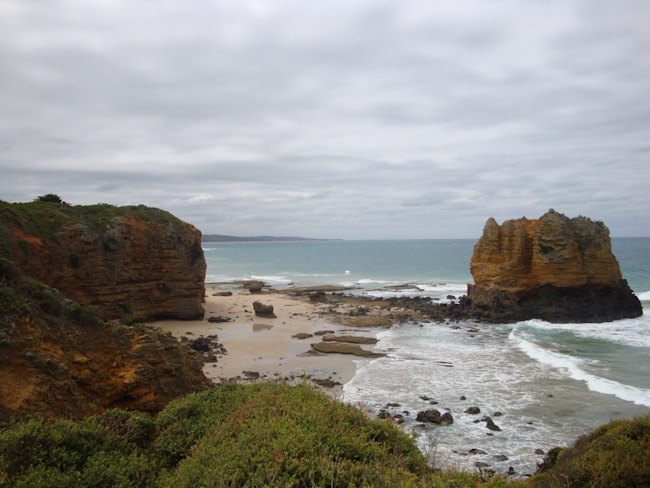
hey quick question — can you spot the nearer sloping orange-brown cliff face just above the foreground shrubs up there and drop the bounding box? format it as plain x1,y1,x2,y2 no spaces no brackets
0,259,209,418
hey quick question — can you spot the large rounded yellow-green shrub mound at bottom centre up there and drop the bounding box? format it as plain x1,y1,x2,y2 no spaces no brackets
158,384,430,487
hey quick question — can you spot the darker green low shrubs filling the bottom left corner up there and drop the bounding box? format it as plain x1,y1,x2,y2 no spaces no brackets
0,412,158,488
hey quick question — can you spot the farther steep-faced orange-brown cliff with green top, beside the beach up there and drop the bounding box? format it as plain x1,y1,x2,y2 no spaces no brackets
0,202,206,323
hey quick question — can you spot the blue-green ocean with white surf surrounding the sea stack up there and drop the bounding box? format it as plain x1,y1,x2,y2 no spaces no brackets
204,238,650,475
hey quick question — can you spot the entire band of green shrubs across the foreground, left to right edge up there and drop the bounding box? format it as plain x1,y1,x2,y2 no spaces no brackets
0,383,650,488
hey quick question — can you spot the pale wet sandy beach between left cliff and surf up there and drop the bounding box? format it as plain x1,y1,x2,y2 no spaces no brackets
151,284,384,396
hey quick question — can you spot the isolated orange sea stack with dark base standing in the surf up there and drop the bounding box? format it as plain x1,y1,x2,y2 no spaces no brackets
464,209,643,322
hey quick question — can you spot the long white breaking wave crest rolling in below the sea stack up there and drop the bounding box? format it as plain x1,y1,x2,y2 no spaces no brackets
509,328,650,407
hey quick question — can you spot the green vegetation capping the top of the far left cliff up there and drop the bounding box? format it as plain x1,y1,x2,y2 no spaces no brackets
0,201,182,240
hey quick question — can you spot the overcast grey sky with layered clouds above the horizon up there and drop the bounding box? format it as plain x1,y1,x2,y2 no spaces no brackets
0,0,650,239
